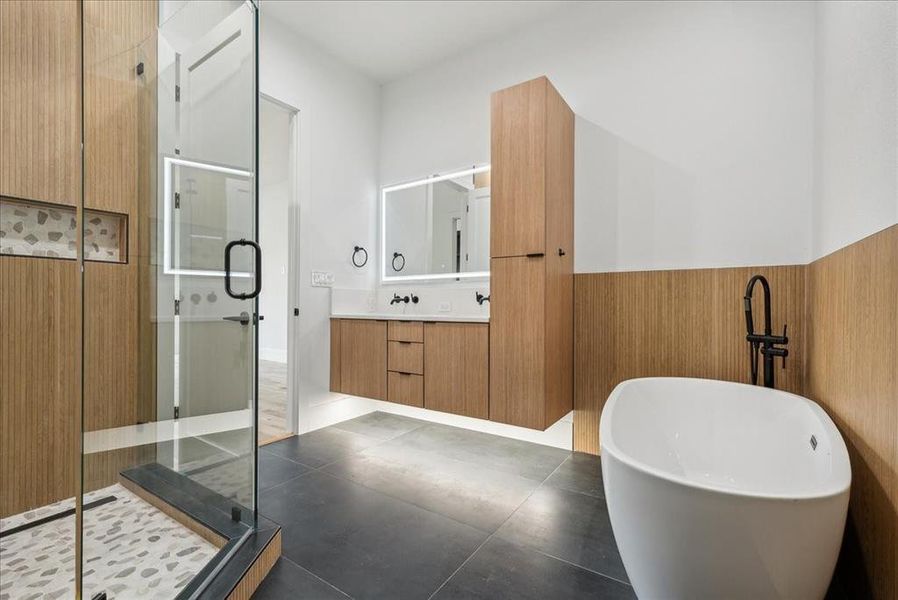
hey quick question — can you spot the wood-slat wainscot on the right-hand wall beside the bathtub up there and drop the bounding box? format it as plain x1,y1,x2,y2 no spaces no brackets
805,225,898,600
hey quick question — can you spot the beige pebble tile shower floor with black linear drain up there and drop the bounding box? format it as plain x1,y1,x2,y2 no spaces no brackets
0,484,218,600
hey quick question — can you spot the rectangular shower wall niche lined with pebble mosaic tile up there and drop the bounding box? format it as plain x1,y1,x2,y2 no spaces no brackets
0,198,128,263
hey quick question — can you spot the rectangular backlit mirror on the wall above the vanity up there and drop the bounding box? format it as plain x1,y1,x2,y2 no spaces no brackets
381,166,490,282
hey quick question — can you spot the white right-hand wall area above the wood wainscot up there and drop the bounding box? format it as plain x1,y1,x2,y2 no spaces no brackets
813,2,898,258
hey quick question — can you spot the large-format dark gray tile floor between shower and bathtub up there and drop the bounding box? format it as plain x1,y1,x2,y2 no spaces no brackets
248,412,635,599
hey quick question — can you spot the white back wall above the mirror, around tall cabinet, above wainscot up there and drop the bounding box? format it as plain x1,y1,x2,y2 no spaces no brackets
380,2,814,272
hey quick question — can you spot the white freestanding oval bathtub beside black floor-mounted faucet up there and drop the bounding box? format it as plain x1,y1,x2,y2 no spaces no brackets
600,378,851,600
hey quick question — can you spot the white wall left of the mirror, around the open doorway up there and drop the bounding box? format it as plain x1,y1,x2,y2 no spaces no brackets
259,15,380,431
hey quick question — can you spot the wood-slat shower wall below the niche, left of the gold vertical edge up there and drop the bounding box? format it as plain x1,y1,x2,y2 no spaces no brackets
0,256,79,517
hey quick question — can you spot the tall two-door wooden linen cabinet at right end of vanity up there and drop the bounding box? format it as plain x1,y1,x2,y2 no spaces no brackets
490,77,574,430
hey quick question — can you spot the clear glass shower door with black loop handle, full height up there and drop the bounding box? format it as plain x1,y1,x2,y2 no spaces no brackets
157,1,261,512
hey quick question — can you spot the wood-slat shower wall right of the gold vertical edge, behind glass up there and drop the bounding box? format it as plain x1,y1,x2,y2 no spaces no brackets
83,0,157,491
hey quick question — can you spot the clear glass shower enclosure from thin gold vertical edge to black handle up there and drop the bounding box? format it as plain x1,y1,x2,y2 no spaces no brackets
76,0,262,598
